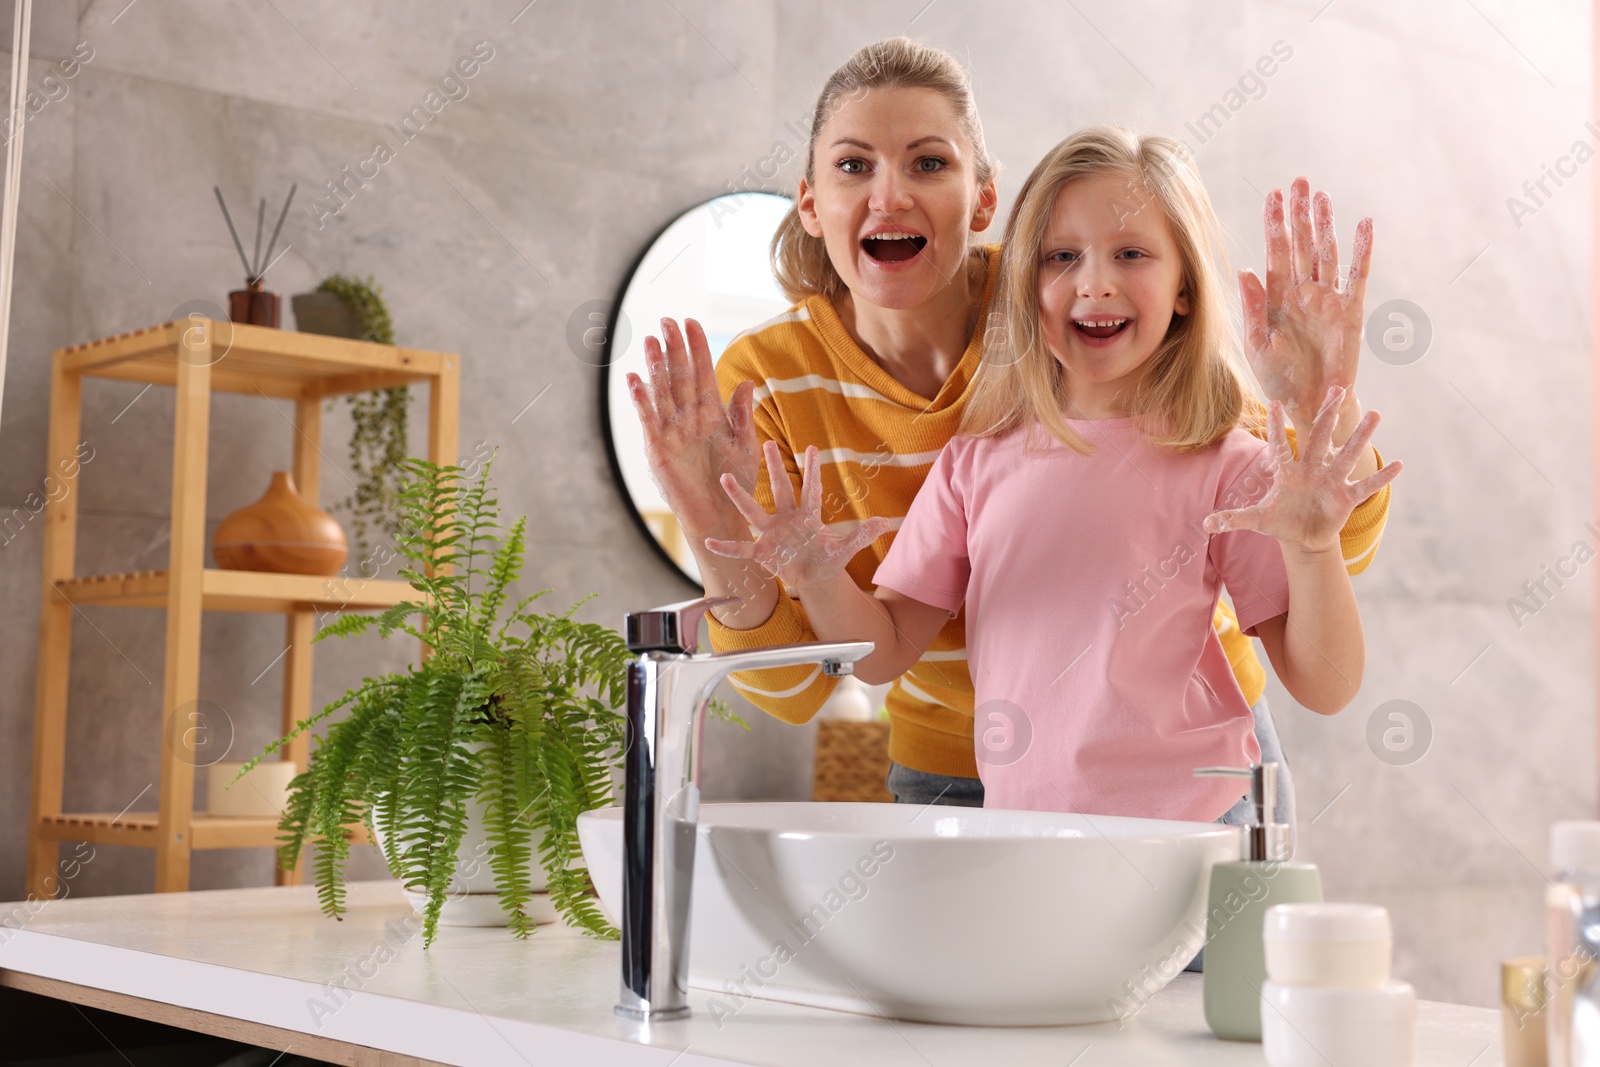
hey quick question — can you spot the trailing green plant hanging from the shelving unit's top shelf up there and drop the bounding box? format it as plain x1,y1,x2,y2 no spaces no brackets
317,274,411,560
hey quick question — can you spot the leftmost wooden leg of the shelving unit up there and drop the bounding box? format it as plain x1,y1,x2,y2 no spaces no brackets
24,358,83,899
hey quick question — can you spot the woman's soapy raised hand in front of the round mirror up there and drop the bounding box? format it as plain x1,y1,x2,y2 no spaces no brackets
627,318,762,534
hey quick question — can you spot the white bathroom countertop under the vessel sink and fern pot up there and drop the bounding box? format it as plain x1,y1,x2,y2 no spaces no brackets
0,881,1501,1067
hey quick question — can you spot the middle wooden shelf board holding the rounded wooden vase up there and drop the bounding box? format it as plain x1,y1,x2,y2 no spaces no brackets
54,568,422,613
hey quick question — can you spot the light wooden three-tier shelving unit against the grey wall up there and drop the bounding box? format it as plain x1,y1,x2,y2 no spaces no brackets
27,317,461,897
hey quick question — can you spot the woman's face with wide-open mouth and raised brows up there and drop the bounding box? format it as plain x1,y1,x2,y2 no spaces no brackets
798,88,997,309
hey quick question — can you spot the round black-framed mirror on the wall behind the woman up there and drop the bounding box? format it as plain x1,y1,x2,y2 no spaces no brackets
595,192,792,584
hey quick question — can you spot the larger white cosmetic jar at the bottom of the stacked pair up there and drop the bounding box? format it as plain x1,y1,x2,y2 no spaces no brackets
1261,979,1416,1067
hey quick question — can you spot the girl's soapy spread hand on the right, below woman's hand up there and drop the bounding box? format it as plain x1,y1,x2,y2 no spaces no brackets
1205,386,1400,552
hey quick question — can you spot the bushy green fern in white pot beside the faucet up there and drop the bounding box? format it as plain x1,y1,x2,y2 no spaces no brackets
235,456,629,945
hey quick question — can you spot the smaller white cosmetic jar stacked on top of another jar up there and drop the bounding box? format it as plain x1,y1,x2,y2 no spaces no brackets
1261,902,1394,989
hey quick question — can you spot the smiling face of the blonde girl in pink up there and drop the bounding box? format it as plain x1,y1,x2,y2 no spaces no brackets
1038,174,1189,419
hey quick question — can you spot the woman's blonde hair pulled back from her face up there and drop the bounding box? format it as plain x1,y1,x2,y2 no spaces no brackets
771,37,994,302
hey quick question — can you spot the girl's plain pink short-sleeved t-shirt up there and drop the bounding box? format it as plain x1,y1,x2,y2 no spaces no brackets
874,419,1288,822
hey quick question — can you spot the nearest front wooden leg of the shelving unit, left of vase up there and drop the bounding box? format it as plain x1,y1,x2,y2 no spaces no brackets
155,328,218,893
